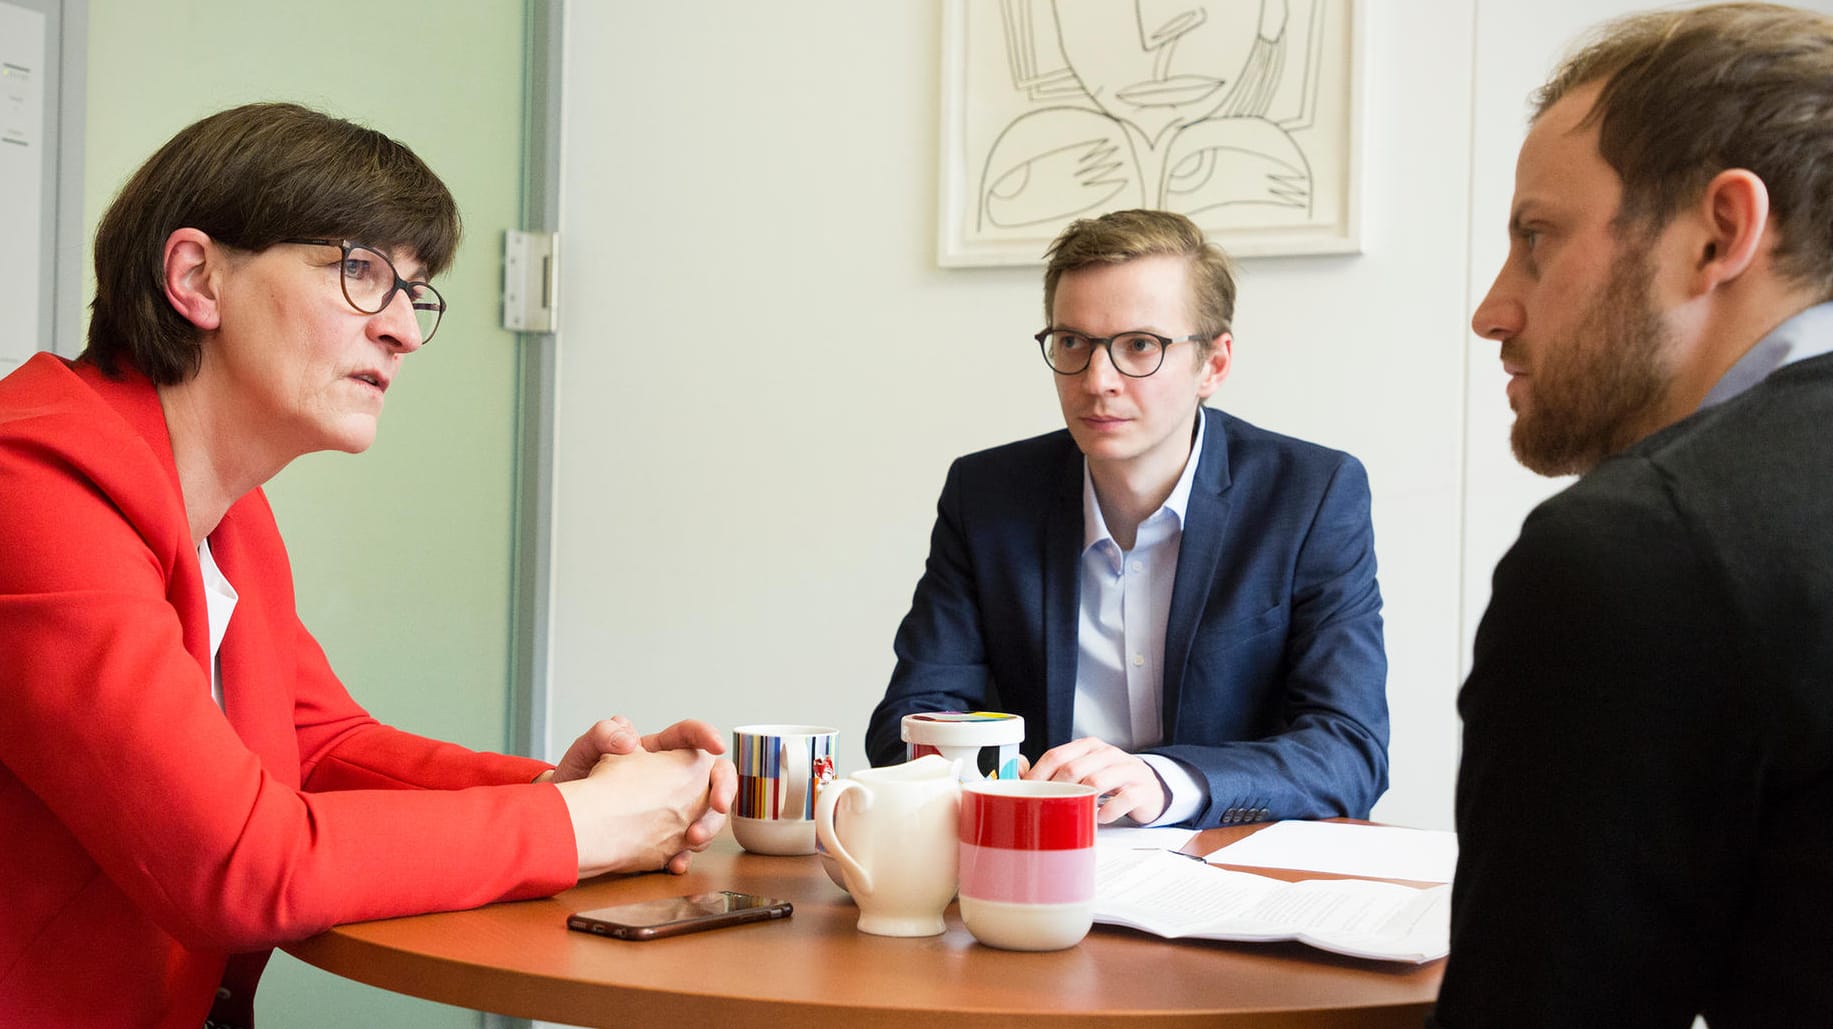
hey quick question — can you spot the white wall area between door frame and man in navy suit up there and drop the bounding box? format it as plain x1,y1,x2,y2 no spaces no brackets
550,0,1056,785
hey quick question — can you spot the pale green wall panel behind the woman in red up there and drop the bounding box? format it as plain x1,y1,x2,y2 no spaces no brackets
84,0,524,1029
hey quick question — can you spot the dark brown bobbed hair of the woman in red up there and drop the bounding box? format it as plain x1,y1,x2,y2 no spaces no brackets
84,103,460,385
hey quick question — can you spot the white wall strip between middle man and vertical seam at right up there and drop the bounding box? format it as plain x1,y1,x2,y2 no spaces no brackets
1219,0,1472,827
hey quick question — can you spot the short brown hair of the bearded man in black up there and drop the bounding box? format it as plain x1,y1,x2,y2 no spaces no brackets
1534,4,1833,297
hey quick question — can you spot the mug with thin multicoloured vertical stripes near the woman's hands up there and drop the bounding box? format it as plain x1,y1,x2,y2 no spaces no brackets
731,725,836,855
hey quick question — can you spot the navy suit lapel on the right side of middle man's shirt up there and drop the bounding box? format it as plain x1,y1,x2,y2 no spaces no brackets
1162,409,1232,743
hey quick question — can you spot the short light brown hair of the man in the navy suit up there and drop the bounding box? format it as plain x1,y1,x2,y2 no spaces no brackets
1043,211,1235,339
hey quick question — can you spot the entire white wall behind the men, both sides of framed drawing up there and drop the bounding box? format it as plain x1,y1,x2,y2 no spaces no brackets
550,0,1781,827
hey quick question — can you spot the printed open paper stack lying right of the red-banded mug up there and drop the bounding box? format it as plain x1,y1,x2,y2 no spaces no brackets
1094,847,1452,963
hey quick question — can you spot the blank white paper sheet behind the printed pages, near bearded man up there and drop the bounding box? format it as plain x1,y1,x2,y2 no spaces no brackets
1210,822,1457,882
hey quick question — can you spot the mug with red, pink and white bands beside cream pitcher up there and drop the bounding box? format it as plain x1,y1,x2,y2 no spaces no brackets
959,780,1096,950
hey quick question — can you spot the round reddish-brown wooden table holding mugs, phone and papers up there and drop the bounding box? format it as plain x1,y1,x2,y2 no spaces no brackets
286,827,1444,1029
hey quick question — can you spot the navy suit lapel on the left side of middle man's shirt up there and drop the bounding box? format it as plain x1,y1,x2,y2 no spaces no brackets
1043,433,1081,747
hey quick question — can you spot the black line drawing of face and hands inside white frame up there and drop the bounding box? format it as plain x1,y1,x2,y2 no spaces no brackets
977,0,1322,229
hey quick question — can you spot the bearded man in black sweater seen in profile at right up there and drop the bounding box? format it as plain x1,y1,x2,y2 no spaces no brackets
1433,4,1833,1029
